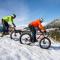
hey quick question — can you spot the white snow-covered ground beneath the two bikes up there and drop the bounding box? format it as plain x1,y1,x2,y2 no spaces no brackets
0,36,60,60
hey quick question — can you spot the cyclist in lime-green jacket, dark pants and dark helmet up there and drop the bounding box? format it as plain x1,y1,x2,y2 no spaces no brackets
2,14,16,35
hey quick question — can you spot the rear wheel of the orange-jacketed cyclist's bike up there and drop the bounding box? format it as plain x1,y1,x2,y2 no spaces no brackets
20,33,31,45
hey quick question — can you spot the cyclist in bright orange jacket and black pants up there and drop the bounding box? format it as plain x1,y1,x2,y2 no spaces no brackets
28,18,46,42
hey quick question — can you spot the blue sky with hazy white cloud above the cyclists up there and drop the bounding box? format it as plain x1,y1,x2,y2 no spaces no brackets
0,0,60,26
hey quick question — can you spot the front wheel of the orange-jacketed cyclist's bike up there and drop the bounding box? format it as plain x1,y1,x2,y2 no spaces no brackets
39,37,51,49
